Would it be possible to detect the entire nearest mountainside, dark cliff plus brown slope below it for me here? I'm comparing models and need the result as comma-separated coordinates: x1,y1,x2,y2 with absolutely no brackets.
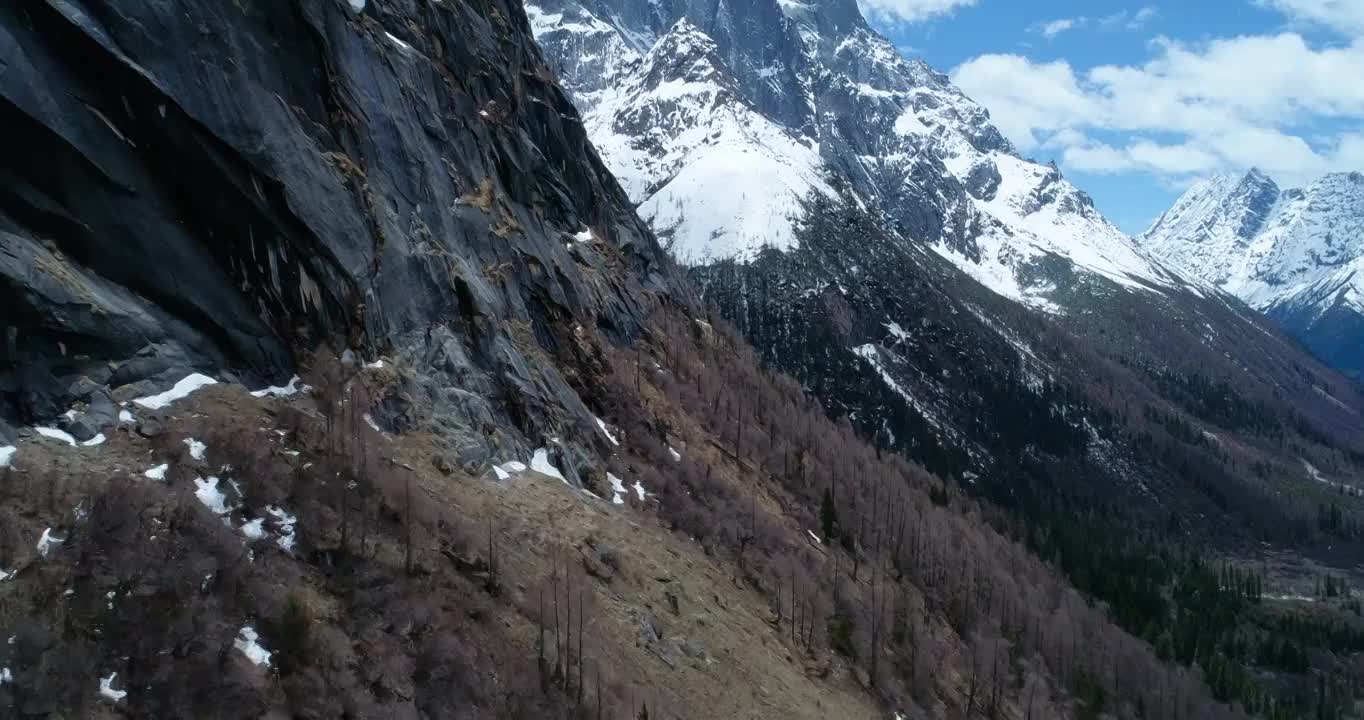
0,0,1249,719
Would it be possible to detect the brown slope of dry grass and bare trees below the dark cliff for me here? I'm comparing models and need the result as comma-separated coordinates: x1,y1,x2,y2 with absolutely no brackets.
0,310,1233,719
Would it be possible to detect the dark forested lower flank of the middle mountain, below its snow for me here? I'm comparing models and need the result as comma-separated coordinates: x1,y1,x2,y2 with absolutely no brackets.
692,190,1364,717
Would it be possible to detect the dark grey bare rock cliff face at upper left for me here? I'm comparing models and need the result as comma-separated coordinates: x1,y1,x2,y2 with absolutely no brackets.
0,0,668,457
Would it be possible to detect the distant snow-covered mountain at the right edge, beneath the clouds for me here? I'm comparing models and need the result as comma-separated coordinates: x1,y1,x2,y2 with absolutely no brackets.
1142,170,1364,378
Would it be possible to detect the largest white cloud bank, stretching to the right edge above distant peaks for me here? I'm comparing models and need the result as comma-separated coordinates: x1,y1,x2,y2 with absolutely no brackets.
952,29,1364,183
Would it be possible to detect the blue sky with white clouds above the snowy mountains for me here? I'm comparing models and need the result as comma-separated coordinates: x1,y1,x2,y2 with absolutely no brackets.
861,0,1364,233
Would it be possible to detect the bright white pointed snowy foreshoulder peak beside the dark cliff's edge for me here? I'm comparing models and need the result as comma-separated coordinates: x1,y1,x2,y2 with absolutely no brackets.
553,12,829,265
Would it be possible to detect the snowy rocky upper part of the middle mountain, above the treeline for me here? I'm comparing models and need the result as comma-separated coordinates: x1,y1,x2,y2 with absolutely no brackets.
527,0,1181,311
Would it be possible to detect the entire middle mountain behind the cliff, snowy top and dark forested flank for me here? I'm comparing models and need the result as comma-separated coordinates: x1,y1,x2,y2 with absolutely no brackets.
528,0,1364,716
